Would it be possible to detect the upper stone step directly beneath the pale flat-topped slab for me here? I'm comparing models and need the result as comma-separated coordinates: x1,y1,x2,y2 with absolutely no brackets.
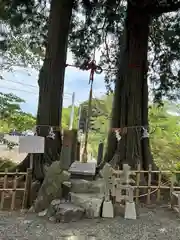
63,179,104,193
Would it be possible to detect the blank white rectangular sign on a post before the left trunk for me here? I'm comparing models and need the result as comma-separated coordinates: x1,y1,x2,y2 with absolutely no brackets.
19,136,44,153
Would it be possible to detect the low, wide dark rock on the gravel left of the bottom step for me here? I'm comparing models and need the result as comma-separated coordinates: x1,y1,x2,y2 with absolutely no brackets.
48,201,84,222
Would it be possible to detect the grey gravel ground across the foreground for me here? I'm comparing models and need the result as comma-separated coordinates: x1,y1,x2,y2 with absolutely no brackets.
0,207,180,240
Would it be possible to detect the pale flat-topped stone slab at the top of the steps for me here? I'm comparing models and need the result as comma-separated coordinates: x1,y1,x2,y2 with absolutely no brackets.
69,161,97,176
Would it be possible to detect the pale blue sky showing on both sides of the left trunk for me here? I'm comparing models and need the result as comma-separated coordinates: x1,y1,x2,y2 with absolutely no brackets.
0,52,106,115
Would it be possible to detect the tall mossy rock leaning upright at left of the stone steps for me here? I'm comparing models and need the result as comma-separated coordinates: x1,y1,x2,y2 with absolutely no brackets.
34,161,70,212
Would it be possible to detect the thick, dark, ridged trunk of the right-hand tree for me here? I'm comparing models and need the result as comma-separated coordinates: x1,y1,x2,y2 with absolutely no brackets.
105,3,153,169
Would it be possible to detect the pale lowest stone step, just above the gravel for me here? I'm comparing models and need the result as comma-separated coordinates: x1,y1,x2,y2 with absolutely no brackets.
70,192,104,218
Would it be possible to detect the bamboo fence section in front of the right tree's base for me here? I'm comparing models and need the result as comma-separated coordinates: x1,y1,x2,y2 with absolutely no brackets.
116,165,180,204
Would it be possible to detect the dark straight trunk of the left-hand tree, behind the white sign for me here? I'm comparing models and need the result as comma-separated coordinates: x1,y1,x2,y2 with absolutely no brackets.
14,0,74,180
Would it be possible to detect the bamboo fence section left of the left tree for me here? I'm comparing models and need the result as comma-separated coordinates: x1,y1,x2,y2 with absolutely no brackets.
0,169,32,210
